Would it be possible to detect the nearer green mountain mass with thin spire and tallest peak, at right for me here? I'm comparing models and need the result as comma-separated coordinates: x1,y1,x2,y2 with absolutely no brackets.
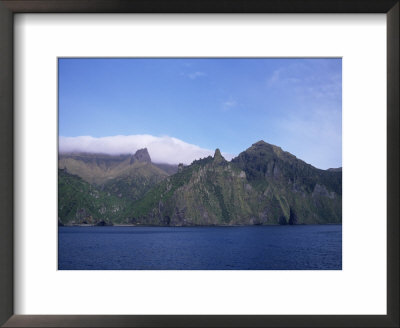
132,141,342,225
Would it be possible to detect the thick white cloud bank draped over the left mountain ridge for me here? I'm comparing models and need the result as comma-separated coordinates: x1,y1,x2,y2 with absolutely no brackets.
59,134,233,164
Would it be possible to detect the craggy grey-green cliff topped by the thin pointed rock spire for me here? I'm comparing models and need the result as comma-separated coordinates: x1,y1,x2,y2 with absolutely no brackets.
133,150,256,225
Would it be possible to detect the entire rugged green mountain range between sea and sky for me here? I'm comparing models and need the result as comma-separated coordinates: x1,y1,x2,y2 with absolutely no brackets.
59,141,342,226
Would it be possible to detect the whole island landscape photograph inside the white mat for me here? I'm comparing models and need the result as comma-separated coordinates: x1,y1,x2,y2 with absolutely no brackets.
57,57,343,270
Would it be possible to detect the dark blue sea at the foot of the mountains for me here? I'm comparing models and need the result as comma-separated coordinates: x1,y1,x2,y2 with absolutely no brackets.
58,225,342,270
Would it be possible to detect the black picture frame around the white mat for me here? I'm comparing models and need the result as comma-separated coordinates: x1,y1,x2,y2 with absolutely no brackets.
0,0,400,327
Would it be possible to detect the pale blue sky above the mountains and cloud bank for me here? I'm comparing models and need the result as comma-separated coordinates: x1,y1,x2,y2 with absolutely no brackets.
59,58,342,169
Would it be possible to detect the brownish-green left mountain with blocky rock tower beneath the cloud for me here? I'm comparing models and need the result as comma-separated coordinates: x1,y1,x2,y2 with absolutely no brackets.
58,148,169,224
